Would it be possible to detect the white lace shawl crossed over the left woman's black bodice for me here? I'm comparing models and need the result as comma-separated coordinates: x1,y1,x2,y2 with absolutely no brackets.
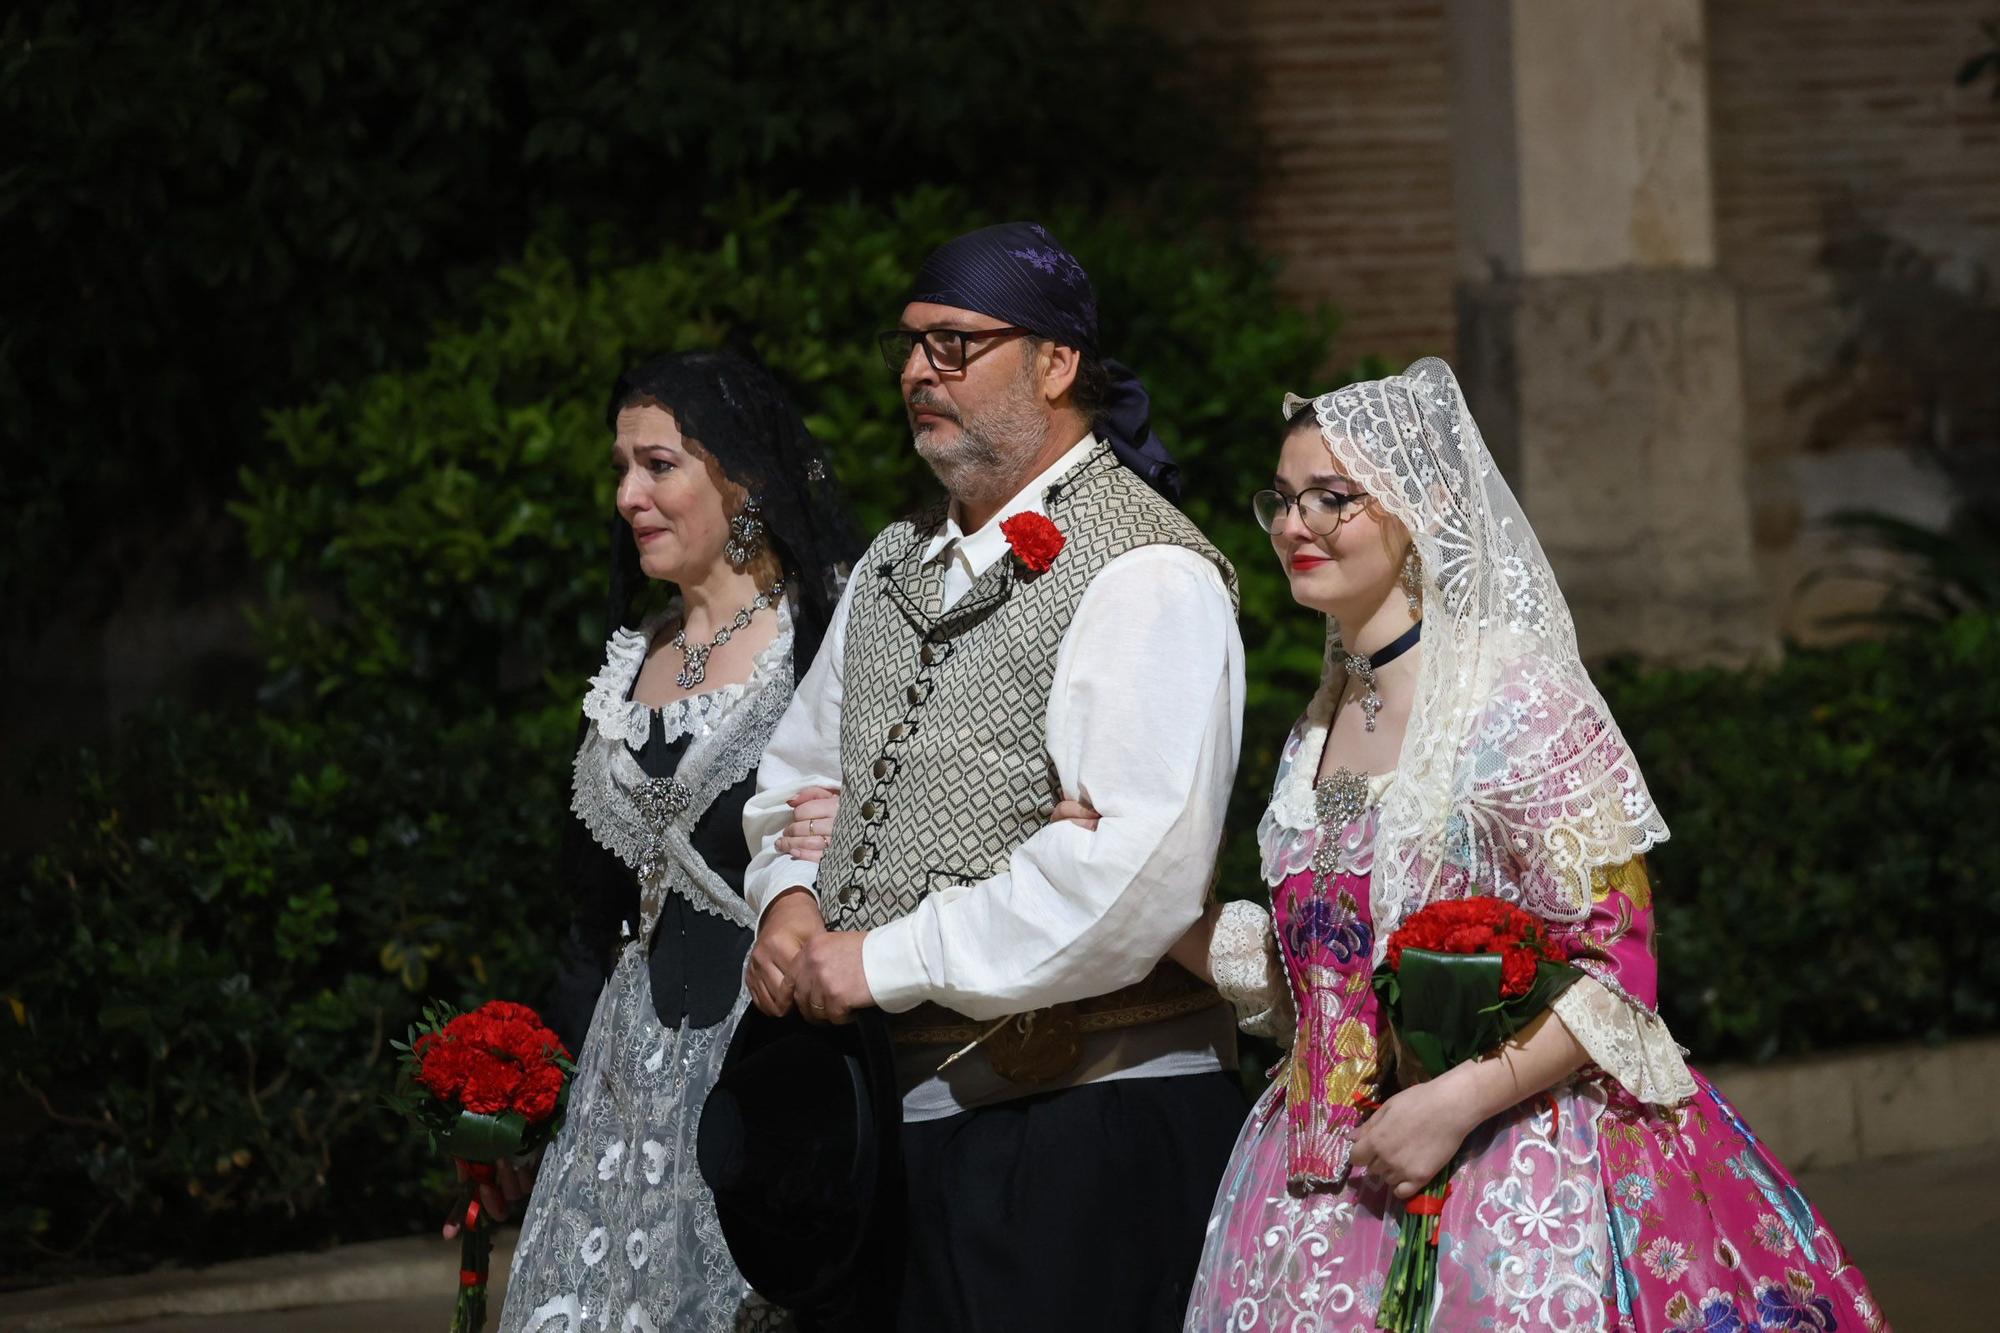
570,602,792,939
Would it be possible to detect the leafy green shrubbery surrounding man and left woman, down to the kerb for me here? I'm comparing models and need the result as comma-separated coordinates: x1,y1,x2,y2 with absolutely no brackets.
0,171,1330,1275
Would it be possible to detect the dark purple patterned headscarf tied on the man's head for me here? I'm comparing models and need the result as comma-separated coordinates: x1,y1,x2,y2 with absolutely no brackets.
910,222,1180,500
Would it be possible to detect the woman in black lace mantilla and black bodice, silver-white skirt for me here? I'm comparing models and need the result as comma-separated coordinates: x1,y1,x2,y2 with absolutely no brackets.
500,352,856,1333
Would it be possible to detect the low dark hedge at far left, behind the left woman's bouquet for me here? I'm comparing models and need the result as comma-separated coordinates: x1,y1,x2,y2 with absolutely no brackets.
0,701,572,1277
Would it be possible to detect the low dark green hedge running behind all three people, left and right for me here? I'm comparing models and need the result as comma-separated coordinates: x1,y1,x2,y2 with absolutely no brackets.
0,618,2000,1275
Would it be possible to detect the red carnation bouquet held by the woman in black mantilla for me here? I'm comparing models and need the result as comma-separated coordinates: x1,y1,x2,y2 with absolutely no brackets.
388,1001,576,1333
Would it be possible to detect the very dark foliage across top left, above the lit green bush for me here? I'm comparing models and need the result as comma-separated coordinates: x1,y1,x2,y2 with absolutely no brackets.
0,0,1252,628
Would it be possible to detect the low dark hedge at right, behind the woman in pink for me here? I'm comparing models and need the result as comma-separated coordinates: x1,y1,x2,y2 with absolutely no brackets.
1604,614,2000,1061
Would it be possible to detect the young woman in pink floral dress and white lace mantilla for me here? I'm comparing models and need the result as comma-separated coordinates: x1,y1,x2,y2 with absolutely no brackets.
1176,360,1888,1333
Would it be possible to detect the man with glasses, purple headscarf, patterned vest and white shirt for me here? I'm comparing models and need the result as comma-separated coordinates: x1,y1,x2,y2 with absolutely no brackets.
744,222,1244,1333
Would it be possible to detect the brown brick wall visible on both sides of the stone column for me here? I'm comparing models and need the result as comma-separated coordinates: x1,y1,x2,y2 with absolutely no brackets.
1138,0,2000,628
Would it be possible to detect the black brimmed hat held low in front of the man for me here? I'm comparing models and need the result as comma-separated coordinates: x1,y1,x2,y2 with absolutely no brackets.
696,1007,904,1329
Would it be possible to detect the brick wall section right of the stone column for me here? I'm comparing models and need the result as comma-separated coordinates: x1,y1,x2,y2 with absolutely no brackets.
1708,0,2000,622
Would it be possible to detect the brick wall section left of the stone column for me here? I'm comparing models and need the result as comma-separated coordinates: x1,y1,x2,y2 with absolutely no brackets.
1140,0,1454,362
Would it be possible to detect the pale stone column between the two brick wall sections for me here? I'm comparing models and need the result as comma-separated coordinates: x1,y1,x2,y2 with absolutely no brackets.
1450,0,1776,662
